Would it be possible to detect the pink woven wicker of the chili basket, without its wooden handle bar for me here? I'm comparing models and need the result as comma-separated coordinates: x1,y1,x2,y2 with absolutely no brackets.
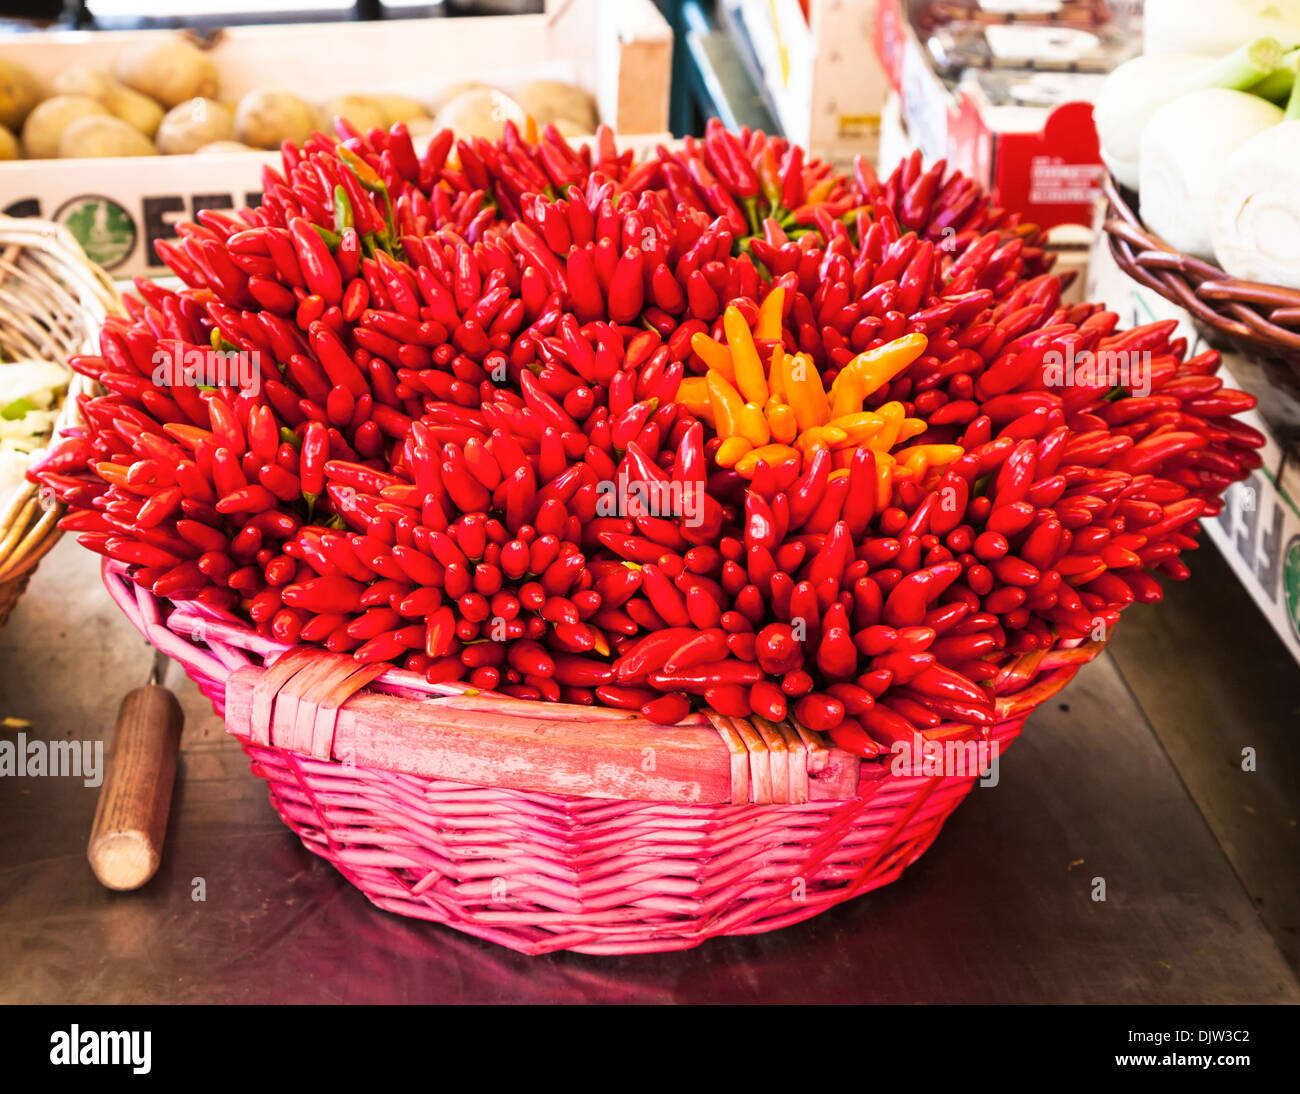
104,563,1100,954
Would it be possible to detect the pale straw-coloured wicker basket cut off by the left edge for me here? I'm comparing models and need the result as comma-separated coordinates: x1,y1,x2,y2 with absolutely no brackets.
0,216,122,626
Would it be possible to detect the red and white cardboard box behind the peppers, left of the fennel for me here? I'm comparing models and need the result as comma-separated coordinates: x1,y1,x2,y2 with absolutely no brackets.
875,0,1104,227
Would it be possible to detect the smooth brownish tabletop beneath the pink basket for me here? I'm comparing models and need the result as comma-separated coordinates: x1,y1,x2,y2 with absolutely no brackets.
0,539,1300,1003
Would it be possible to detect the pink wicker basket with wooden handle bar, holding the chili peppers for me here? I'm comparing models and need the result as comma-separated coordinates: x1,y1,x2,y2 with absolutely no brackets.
104,563,1101,954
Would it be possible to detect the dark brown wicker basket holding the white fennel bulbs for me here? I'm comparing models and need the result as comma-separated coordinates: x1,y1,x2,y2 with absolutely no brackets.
1102,175,1300,388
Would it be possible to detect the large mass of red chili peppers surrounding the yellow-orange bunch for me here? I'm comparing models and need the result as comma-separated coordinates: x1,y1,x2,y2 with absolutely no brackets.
35,114,1262,756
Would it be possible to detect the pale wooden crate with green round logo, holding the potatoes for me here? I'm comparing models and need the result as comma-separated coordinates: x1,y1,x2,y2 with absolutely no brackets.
0,0,672,277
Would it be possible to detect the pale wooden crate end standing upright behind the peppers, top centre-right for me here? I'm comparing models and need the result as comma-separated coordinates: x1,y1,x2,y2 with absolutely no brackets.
722,0,889,170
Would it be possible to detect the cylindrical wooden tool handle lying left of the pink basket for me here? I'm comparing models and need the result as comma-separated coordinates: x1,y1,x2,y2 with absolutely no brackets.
86,685,185,889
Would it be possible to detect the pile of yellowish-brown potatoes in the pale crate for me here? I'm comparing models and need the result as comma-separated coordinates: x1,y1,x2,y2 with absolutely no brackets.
0,38,598,160
